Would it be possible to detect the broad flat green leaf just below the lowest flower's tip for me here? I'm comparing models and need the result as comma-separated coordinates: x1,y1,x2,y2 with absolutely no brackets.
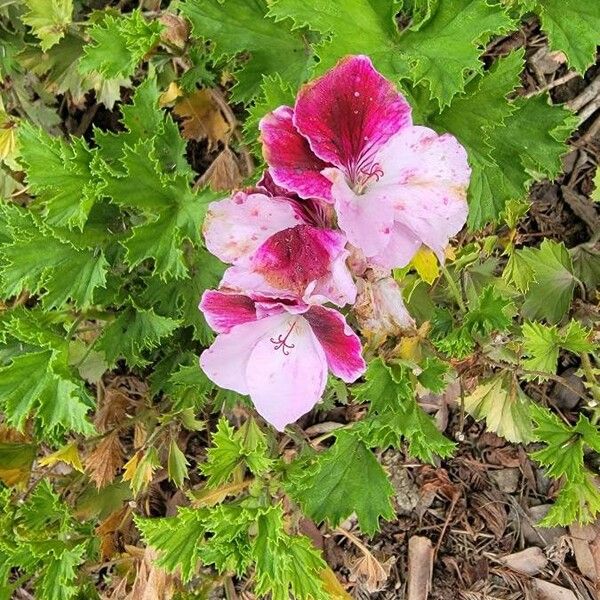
288,431,394,535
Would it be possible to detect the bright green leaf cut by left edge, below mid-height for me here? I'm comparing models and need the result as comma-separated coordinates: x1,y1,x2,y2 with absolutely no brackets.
0,350,94,439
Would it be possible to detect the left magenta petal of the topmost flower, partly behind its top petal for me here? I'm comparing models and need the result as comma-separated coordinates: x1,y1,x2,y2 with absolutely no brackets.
259,106,331,200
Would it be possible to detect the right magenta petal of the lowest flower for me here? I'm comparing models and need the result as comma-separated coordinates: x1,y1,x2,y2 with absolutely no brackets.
304,306,366,383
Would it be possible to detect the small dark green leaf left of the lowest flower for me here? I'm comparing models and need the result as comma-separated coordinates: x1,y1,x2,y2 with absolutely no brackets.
95,304,179,366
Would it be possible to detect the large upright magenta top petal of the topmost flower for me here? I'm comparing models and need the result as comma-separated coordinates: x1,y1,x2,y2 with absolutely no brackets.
293,56,412,173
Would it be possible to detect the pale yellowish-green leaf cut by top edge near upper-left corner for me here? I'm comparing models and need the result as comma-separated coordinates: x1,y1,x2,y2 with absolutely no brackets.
22,0,73,52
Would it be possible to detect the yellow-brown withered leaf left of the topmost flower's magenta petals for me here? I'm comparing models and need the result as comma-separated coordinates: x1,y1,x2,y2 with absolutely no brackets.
173,90,231,149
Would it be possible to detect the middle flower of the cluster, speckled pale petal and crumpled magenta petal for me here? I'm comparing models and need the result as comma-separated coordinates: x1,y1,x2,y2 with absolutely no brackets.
204,188,356,306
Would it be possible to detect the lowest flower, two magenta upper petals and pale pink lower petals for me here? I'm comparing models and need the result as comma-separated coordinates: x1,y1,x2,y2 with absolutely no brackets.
200,291,365,431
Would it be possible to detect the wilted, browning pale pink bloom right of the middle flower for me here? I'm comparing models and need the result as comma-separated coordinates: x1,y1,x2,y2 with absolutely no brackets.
352,277,415,346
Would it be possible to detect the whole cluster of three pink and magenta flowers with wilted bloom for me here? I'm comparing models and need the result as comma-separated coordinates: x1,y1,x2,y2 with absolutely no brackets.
200,56,470,430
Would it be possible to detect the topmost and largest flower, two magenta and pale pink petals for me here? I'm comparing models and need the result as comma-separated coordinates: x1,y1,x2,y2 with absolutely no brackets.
260,56,471,269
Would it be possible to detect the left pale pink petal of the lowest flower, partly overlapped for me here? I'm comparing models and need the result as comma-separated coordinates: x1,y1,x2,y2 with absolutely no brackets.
200,310,289,394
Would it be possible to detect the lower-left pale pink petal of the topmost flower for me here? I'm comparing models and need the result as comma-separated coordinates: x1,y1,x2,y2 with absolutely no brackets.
324,169,394,257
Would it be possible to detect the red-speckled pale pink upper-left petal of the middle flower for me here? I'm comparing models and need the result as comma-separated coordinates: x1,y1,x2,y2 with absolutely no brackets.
204,192,302,264
